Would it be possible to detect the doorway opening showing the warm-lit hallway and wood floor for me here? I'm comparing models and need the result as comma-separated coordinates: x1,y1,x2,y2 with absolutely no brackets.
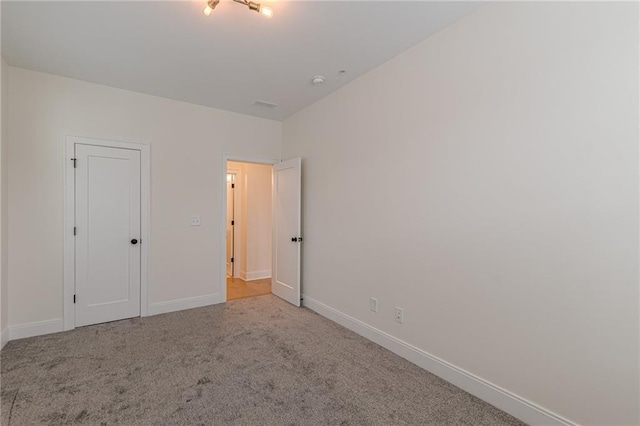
226,161,273,301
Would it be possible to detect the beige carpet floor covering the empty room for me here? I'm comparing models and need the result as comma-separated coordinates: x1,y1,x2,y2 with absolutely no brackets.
0,295,521,426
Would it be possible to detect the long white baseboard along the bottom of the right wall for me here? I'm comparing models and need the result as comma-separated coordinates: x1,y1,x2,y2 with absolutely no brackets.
303,295,576,426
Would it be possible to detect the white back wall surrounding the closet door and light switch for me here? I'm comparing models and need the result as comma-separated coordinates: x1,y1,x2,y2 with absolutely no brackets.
8,67,281,325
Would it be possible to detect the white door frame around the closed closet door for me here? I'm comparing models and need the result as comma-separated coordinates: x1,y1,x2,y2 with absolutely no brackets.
62,136,151,331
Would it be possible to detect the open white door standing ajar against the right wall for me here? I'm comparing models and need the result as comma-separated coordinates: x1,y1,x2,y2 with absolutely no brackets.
271,158,302,306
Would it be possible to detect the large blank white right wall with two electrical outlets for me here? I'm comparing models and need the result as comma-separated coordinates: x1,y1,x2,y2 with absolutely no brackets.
283,2,640,425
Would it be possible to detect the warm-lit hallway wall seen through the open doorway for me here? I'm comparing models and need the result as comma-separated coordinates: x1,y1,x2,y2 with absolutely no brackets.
228,161,273,281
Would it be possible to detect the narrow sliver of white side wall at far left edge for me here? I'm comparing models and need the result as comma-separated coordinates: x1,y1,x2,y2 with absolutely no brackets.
0,58,9,344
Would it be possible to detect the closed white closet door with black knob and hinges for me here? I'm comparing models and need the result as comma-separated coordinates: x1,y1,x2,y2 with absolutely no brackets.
75,144,141,327
